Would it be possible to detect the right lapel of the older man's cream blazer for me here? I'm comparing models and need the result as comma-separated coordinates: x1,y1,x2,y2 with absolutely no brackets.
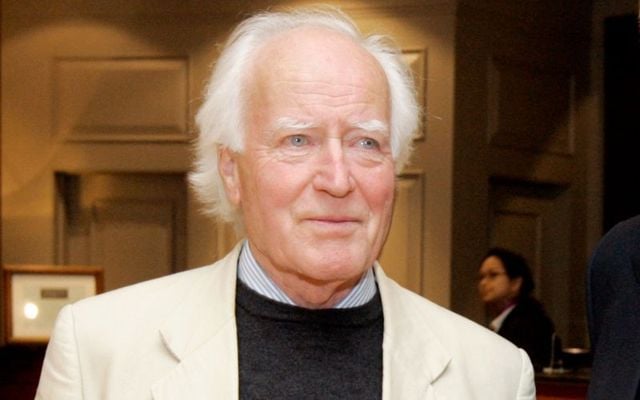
375,265,451,400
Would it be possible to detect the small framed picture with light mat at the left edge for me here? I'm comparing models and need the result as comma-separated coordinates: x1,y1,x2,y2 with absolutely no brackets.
2,265,104,343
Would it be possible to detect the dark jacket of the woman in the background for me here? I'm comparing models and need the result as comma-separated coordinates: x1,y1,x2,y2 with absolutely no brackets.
498,297,555,371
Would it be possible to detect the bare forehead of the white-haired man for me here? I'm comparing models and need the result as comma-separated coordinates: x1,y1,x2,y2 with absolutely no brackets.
247,28,390,131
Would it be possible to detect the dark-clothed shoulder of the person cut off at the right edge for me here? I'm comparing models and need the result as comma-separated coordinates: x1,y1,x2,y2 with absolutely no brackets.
587,215,640,400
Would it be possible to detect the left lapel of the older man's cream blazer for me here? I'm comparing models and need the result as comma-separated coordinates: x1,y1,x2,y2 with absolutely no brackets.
152,245,240,400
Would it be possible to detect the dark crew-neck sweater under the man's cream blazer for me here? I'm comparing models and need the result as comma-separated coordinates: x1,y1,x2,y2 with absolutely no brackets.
236,281,383,400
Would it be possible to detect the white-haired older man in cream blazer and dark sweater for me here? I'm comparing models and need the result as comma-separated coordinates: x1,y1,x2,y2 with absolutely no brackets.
38,9,535,400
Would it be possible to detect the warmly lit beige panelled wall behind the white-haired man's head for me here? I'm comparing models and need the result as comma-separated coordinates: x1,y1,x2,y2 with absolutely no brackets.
2,1,454,294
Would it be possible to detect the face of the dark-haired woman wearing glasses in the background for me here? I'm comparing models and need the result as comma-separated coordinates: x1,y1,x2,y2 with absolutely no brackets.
478,256,522,306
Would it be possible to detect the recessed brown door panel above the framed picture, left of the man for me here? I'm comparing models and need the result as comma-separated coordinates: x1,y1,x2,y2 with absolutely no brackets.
57,173,186,290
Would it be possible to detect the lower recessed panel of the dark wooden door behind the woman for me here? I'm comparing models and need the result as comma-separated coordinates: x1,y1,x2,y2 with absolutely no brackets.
489,181,568,346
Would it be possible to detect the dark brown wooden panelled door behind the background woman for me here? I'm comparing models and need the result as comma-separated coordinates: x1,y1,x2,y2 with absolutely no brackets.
452,0,600,346
